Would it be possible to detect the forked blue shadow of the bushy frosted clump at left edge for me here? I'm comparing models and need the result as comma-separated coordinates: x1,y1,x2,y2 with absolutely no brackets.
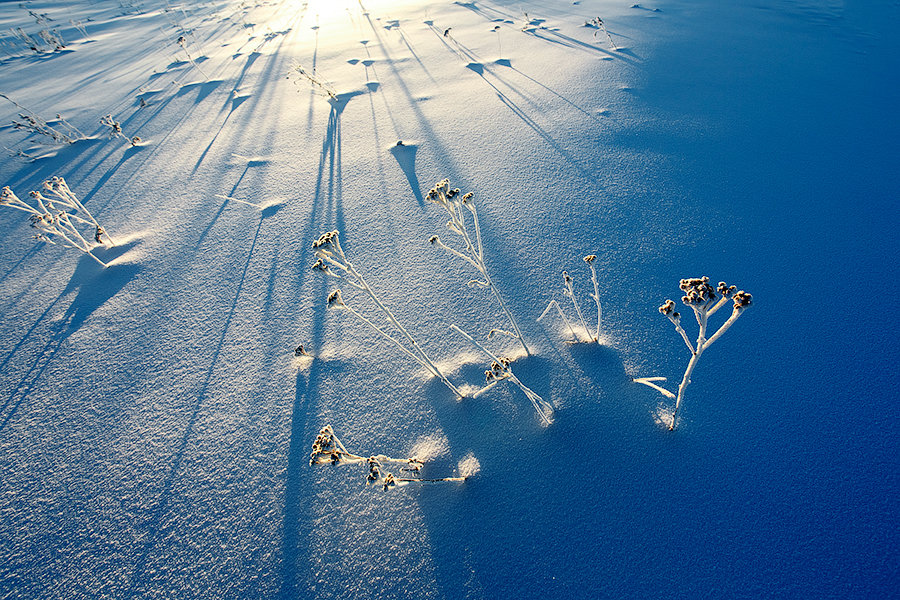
0,243,141,431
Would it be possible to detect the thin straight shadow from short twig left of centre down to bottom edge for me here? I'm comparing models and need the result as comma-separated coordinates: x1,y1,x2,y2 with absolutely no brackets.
123,218,263,598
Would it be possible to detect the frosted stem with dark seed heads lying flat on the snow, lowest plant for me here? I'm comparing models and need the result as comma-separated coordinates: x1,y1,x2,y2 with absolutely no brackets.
309,425,468,490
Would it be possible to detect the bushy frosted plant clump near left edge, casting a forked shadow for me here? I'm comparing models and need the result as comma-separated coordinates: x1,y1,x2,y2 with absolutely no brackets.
0,177,115,267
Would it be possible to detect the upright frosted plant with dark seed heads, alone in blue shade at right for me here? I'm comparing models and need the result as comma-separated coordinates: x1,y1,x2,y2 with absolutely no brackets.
634,277,753,431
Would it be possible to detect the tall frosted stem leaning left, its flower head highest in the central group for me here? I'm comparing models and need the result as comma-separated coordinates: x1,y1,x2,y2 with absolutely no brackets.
426,179,531,356
